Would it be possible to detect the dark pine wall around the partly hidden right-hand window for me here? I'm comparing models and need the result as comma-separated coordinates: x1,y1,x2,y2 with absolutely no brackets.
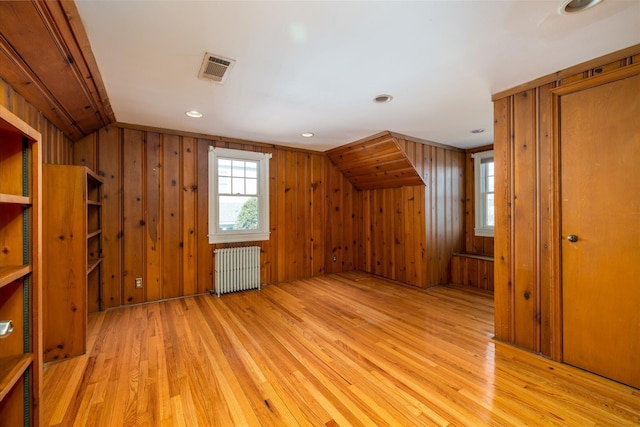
464,145,493,256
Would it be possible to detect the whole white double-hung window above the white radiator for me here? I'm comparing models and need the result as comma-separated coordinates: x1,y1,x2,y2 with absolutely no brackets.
209,147,271,243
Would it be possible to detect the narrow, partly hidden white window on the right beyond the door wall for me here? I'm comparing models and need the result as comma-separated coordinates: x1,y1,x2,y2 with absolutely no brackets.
473,150,495,237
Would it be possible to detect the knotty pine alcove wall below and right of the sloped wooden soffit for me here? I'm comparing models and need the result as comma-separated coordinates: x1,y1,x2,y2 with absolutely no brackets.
355,137,465,287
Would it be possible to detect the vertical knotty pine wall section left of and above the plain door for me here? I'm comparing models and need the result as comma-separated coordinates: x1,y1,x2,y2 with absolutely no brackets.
493,45,640,360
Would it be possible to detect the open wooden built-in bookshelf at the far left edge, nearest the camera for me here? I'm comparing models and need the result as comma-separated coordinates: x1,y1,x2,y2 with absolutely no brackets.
0,105,42,426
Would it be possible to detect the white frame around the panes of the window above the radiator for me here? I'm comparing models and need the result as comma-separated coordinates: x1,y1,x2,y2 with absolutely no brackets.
208,146,271,244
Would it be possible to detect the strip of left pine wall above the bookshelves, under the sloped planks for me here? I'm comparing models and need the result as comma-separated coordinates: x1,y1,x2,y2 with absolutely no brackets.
0,79,73,164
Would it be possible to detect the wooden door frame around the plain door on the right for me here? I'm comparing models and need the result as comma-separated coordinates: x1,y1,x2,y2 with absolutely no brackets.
549,63,640,362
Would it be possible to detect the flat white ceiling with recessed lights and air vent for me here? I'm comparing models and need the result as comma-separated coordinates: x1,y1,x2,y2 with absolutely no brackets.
76,0,640,151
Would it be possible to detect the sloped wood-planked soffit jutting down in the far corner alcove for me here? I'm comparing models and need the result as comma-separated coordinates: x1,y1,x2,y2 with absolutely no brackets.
326,131,425,190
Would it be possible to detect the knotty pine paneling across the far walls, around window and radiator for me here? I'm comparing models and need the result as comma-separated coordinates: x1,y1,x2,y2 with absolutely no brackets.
75,126,465,307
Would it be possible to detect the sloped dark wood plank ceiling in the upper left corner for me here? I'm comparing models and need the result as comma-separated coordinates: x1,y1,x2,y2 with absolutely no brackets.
0,0,115,141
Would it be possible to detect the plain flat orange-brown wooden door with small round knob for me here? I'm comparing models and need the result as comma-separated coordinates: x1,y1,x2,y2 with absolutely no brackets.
559,70,640,387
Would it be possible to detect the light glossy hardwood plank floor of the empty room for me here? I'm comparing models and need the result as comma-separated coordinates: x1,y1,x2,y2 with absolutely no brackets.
43,273,640,426
